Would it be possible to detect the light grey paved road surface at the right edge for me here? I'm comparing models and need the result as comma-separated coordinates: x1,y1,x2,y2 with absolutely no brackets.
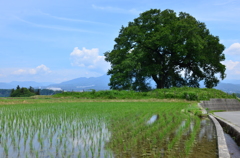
214,111,240,127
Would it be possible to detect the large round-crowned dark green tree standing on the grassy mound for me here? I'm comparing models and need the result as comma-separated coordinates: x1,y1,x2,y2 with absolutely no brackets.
105,9,226,91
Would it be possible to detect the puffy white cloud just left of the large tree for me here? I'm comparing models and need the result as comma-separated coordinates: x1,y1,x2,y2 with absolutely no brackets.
70,47,110,72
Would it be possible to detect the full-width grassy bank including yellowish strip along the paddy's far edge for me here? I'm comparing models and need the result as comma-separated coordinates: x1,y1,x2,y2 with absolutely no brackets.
0,87,237,104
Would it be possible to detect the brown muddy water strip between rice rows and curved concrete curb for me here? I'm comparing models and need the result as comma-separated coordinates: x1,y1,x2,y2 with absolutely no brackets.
189,118,218,158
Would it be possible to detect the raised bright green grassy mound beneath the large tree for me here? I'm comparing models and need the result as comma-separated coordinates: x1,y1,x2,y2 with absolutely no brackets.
53,87,235,101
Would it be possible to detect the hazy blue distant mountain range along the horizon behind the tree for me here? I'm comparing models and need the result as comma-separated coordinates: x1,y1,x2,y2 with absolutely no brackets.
0,75,240,93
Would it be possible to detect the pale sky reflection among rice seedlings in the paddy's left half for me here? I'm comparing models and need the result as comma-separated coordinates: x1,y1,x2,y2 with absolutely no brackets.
0,117,113,158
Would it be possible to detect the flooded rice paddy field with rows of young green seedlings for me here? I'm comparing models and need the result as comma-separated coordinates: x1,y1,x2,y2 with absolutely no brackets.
0,99,217,158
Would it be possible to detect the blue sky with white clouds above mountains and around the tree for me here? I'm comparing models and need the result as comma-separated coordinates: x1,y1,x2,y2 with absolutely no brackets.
0,0,240,83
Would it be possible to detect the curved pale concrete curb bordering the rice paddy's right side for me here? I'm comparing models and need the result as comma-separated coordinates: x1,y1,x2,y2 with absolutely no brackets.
208,115,231,158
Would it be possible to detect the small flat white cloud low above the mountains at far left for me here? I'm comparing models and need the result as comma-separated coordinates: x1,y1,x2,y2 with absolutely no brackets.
12,64,51,75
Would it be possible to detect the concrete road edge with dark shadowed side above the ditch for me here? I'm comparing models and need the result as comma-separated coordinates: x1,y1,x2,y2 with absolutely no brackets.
213,115,240,145
